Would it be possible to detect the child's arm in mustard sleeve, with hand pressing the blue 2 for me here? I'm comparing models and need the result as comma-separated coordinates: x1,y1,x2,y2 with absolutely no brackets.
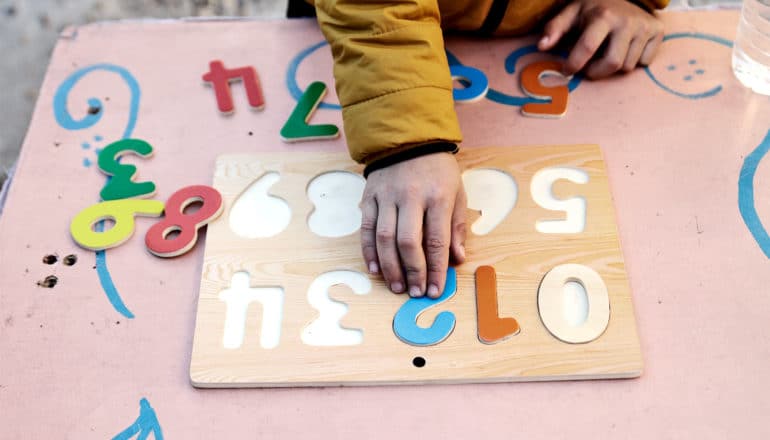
315,0,466,297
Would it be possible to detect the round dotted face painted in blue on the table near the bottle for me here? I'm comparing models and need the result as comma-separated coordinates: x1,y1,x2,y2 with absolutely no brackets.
645,33,732,99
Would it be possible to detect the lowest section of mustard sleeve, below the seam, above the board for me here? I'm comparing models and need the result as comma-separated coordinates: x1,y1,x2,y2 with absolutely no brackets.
342,86,462,165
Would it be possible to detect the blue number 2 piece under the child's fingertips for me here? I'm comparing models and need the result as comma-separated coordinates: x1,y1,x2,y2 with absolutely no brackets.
393,267,457,347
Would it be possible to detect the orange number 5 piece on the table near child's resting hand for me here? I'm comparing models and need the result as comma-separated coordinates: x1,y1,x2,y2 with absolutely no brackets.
519,61,569,118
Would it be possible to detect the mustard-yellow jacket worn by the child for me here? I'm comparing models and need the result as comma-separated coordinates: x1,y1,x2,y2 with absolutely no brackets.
310,0,668,170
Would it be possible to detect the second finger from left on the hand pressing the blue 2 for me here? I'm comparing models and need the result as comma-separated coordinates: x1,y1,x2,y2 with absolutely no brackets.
375,200,404,293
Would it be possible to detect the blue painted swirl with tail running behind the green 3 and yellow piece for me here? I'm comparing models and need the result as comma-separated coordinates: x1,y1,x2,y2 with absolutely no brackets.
53,64,141,319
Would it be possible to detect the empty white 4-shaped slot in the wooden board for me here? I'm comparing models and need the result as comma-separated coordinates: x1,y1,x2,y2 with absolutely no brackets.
219,272,284,350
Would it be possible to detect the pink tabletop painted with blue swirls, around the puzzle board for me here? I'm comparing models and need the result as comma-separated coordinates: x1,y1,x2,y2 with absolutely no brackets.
0,11,770,440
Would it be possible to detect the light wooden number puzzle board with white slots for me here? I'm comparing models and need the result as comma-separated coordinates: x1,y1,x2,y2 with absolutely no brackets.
190,146,642,387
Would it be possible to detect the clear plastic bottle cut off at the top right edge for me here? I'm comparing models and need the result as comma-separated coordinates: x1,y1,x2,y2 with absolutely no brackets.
733,0,770,95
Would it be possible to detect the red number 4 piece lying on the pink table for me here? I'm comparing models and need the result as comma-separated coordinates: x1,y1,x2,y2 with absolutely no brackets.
203,60,265,115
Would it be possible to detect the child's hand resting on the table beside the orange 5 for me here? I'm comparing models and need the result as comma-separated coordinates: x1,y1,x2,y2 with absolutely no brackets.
538,0,663,79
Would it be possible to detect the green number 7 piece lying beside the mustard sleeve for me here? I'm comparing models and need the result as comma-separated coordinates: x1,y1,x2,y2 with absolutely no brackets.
281,81,340,142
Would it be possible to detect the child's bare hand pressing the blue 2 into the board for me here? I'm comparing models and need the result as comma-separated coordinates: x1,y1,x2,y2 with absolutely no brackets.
361,153,467,298
